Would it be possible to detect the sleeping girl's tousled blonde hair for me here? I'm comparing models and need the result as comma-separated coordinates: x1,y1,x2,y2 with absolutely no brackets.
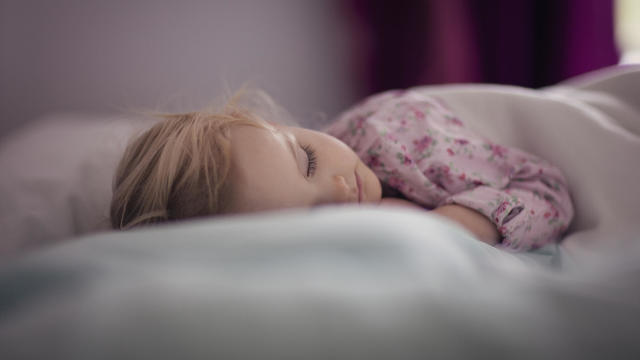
110,90,288,229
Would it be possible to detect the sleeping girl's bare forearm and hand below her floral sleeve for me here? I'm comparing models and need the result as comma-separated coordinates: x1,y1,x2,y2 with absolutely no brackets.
380,198,500,245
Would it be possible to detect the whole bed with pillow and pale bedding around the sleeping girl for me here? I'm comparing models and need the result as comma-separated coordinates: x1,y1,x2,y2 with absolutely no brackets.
0,66,640,359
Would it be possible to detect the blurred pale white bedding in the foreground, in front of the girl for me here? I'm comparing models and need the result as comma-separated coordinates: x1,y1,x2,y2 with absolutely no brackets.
0,207,640,360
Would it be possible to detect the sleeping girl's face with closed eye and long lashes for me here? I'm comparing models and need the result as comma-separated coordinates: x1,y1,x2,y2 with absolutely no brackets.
230,125,381,212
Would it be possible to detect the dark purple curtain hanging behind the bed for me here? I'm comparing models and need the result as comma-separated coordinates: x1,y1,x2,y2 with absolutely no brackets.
345,0,618,93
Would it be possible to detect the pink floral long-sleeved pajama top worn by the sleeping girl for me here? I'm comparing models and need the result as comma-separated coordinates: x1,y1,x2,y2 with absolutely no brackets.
327,90,573,251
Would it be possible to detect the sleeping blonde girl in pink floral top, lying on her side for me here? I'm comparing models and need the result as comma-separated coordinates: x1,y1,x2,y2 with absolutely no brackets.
111,90,573,251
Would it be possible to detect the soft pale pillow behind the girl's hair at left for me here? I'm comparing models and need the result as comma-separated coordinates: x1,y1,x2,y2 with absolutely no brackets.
0,114,148,255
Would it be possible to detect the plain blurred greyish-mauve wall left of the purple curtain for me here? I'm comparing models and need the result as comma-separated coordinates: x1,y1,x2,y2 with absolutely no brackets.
0,0,355,138
